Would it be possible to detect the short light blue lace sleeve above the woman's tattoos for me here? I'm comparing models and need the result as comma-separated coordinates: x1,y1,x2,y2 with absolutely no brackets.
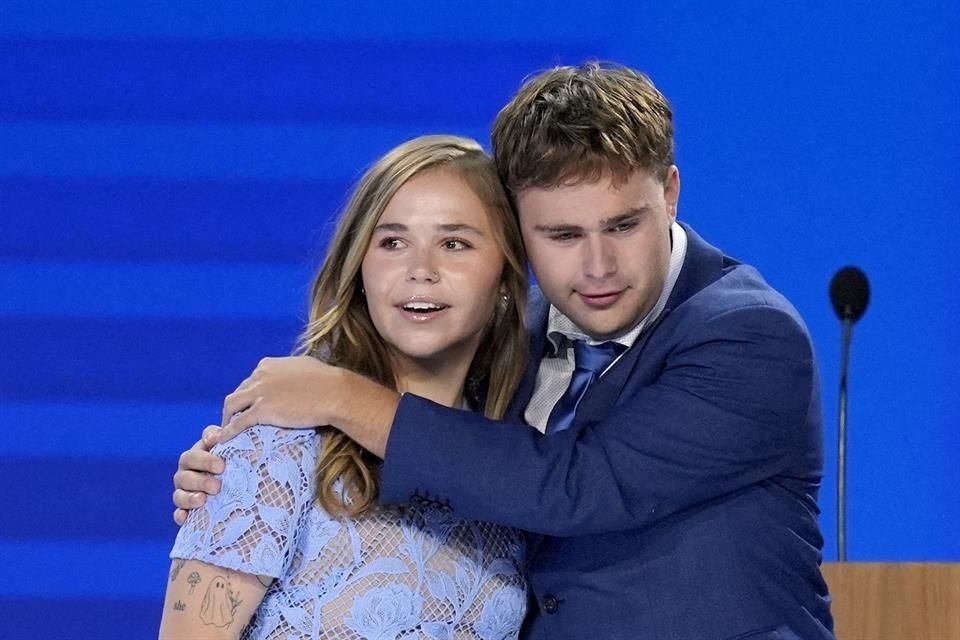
170,426,320,578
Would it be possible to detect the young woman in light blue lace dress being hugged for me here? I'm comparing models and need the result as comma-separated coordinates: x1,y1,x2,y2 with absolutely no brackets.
160,136,527,640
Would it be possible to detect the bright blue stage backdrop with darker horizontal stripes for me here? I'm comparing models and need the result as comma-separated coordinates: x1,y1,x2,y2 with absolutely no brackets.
0,0,960,640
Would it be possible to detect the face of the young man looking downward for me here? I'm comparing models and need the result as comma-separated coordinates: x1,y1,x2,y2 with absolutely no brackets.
517,166,680,340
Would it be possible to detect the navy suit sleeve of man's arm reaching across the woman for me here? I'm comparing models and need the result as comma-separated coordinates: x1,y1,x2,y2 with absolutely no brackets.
381,306,814,536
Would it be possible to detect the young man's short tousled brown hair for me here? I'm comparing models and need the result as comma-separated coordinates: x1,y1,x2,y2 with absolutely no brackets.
493,62,674,194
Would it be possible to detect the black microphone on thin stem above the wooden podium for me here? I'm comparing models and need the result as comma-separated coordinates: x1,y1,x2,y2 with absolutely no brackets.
830,266,870,562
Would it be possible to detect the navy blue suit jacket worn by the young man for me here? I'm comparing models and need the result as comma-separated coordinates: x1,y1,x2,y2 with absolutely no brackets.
381,227,833,640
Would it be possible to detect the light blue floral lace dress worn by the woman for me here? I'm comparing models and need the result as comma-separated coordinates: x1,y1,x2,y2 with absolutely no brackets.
170,427,526,640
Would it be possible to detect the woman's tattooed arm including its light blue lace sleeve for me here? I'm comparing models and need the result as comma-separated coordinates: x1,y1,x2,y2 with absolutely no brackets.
160,426,319,639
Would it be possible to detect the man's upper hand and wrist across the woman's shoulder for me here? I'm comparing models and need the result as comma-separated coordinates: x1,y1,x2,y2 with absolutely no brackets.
212,356,400,456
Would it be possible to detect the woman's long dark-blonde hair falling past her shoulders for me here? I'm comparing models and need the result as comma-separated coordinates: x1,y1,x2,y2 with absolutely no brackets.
297,135,527,517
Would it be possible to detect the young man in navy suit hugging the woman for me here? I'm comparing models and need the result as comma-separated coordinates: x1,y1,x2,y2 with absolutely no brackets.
175,64,833,640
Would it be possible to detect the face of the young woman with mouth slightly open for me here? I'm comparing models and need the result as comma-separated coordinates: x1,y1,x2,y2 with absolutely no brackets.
361,168,504,366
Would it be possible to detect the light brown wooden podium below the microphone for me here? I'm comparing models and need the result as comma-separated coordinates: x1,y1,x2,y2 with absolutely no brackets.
823,562,960,640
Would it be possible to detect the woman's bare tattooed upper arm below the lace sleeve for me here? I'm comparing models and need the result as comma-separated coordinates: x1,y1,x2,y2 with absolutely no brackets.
160,558,273,640
